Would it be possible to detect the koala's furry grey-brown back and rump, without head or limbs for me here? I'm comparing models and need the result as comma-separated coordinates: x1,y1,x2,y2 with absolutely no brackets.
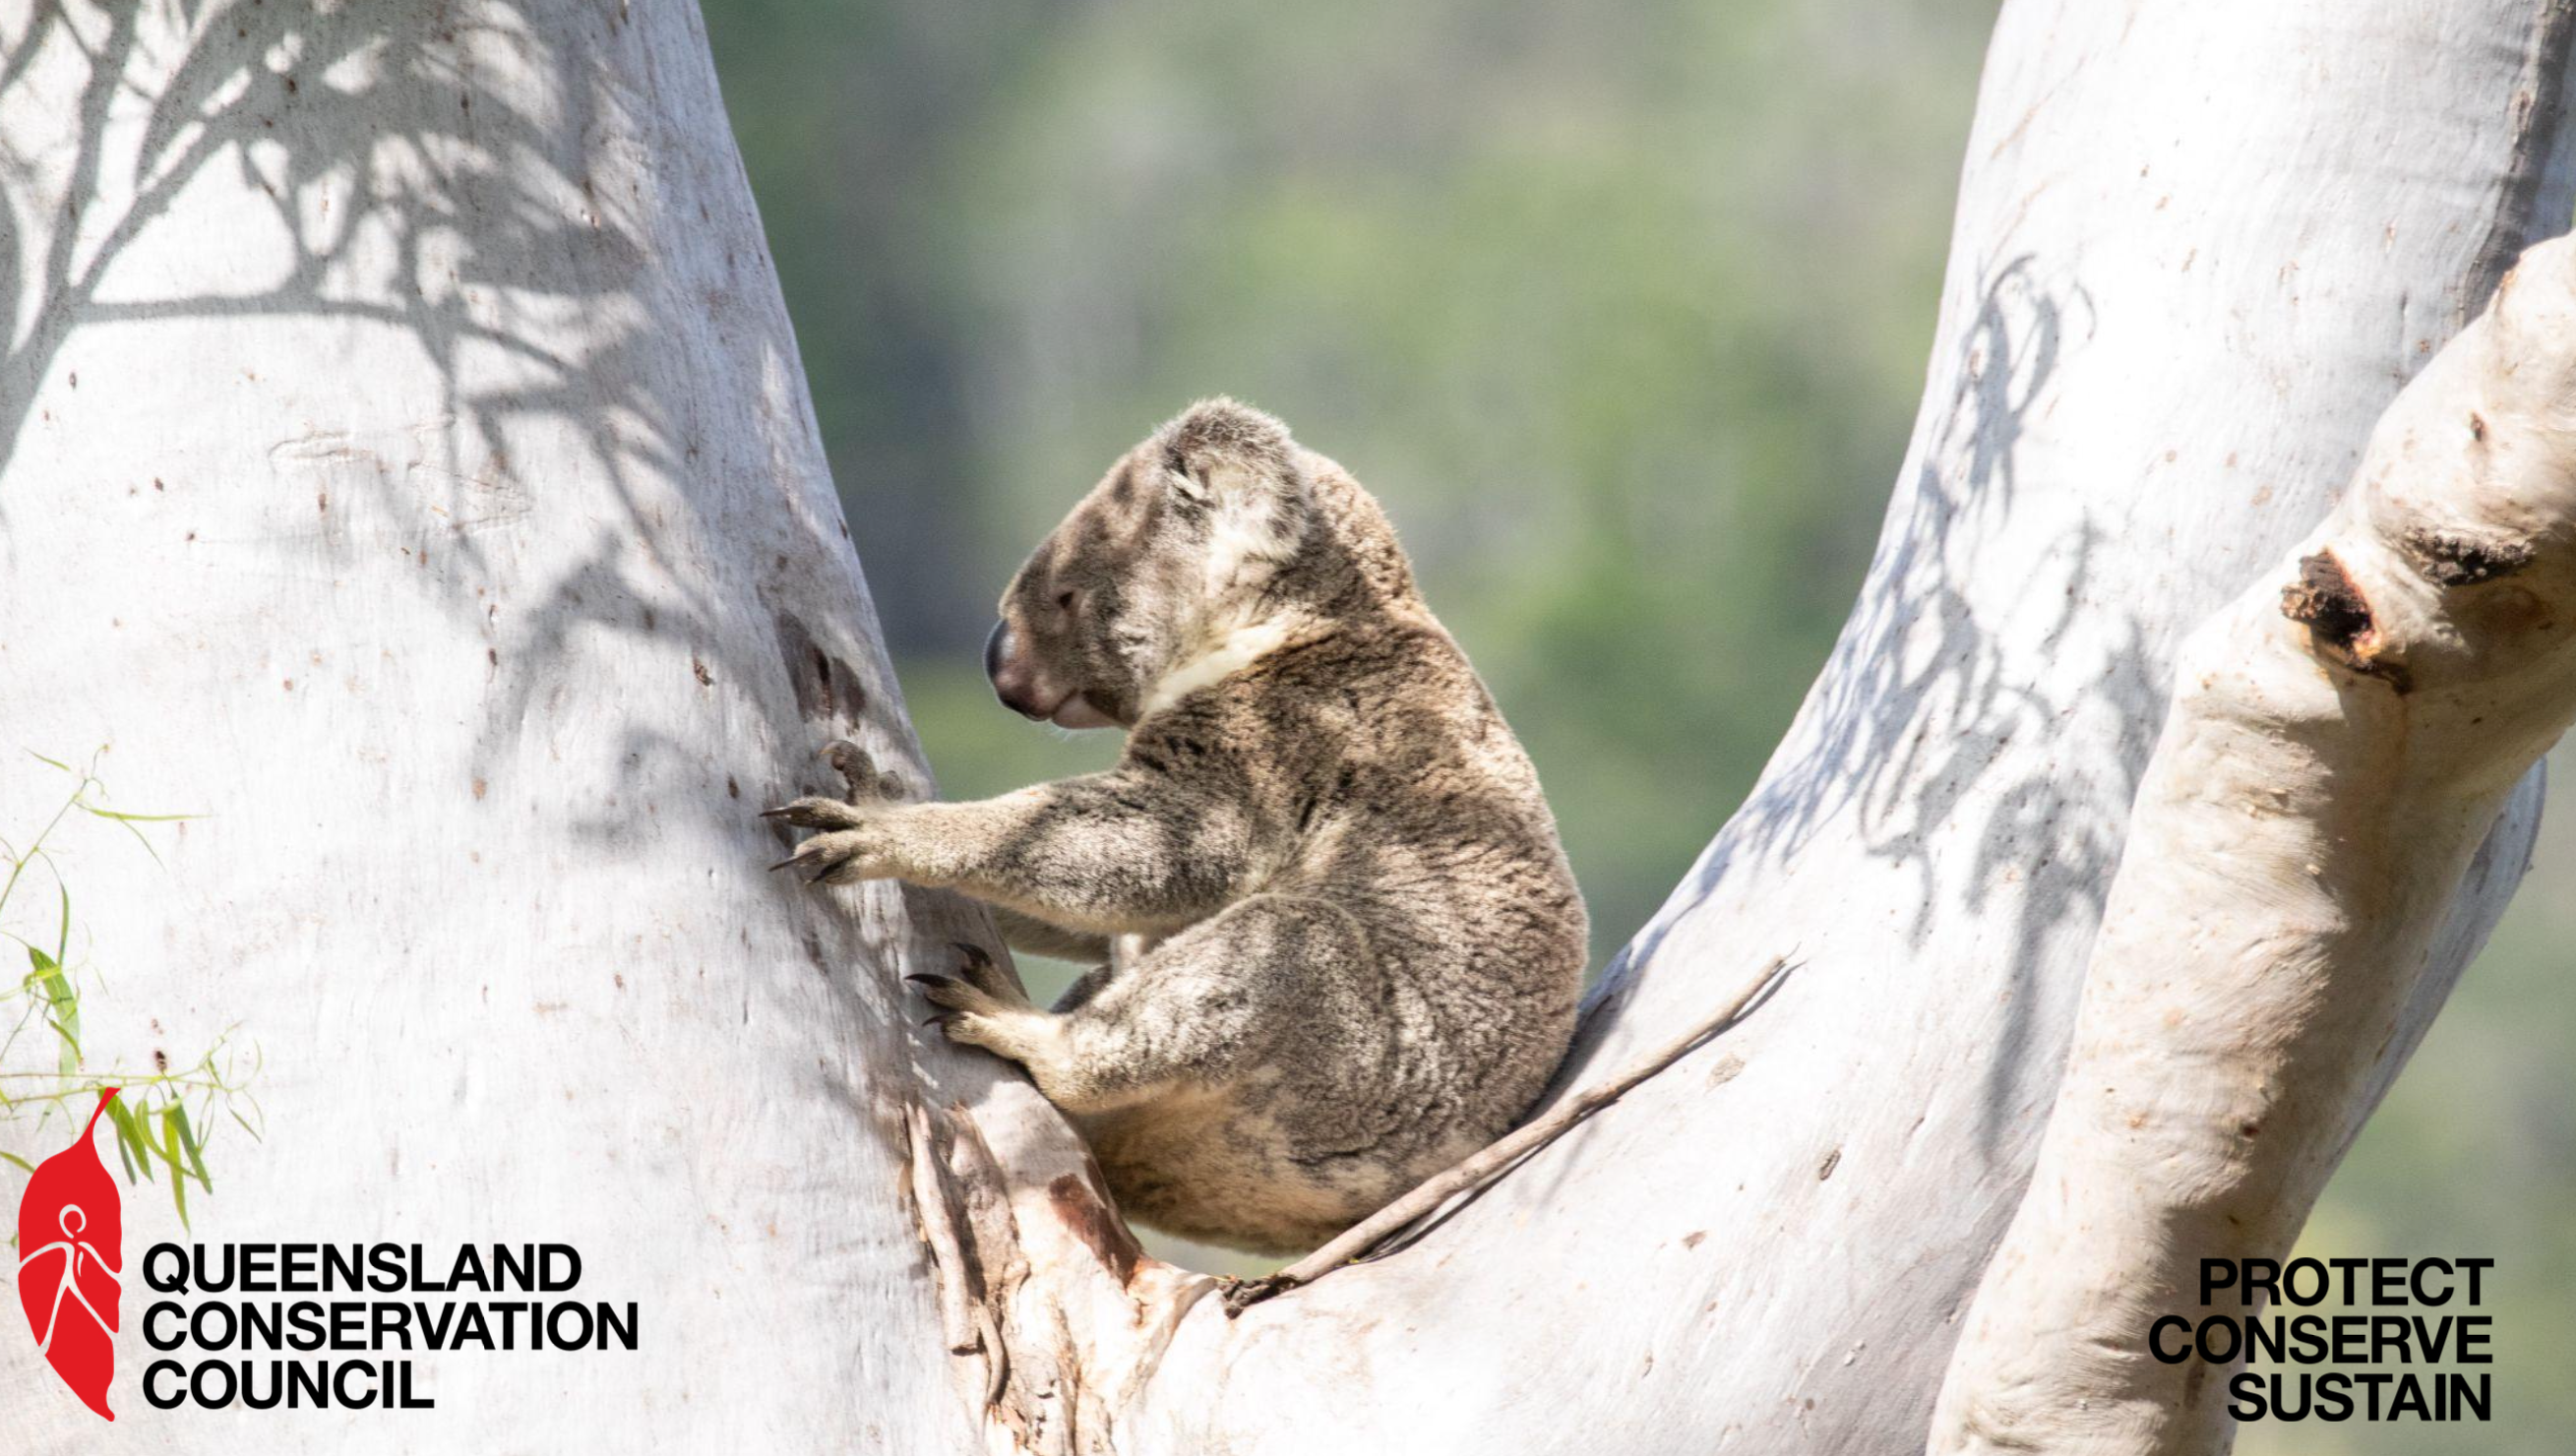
1082,461,1587,1249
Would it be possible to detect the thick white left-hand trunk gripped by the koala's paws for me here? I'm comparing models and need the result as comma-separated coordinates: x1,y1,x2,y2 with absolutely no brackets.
0,0,1056,1453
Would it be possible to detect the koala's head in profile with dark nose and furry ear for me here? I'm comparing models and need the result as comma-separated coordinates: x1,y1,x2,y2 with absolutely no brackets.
984,402,1306,729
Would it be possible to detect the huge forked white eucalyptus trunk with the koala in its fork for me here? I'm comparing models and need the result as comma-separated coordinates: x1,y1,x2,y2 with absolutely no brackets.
0,0,2576,1453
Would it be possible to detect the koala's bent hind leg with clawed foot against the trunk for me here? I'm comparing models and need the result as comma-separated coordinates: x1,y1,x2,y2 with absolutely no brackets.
914,894,1376,1114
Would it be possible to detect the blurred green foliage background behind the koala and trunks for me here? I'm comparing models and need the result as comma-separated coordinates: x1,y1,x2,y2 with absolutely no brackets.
705,0,2576,1456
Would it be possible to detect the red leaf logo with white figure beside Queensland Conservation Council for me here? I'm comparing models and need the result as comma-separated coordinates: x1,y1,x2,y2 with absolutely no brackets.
18,1087,126,1420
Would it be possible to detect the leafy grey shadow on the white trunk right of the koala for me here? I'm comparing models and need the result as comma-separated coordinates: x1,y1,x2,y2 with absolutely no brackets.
1551,253,2167,1144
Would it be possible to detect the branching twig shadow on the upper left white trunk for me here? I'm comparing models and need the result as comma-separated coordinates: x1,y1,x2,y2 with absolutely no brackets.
0,0,917,793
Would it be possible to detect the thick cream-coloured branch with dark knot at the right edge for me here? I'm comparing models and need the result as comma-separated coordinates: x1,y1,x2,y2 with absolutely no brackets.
1932,240,2576,1456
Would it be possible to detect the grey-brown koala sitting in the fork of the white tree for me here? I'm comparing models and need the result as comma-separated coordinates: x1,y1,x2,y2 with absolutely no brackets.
770,399,1584,1255
